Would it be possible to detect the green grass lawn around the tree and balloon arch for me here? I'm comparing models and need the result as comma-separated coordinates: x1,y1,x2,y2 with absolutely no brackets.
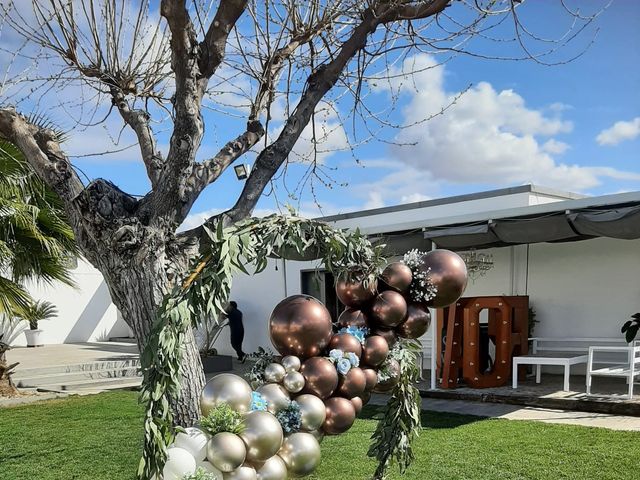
0,392,640,480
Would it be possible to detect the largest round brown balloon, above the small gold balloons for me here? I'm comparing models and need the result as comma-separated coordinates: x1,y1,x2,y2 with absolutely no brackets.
269,295,333,358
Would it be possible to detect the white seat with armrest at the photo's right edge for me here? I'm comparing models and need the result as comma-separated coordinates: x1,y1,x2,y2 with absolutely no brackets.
587,341,640,400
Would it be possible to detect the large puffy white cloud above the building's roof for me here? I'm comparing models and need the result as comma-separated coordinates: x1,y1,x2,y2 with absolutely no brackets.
378,55,636,194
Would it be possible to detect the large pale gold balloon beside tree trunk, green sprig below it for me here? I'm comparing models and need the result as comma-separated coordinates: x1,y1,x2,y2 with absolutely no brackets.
200,373,252,416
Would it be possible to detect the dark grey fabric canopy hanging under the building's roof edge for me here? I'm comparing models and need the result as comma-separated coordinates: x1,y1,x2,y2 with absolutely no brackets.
424,204,640,250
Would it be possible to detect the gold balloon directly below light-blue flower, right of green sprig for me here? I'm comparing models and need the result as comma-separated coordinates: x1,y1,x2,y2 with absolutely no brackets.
240,411,284,462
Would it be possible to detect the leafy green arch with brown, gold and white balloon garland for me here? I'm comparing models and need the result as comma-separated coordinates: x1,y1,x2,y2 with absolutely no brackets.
139,217,466,480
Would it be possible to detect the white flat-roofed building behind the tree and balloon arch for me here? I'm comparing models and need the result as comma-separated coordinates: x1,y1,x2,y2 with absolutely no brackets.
12,185,640,366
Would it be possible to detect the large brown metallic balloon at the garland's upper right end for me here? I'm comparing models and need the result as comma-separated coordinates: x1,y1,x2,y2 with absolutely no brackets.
419,250,468,308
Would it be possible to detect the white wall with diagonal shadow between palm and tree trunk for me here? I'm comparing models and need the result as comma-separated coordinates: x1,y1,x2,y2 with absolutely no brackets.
15,259,129,346
